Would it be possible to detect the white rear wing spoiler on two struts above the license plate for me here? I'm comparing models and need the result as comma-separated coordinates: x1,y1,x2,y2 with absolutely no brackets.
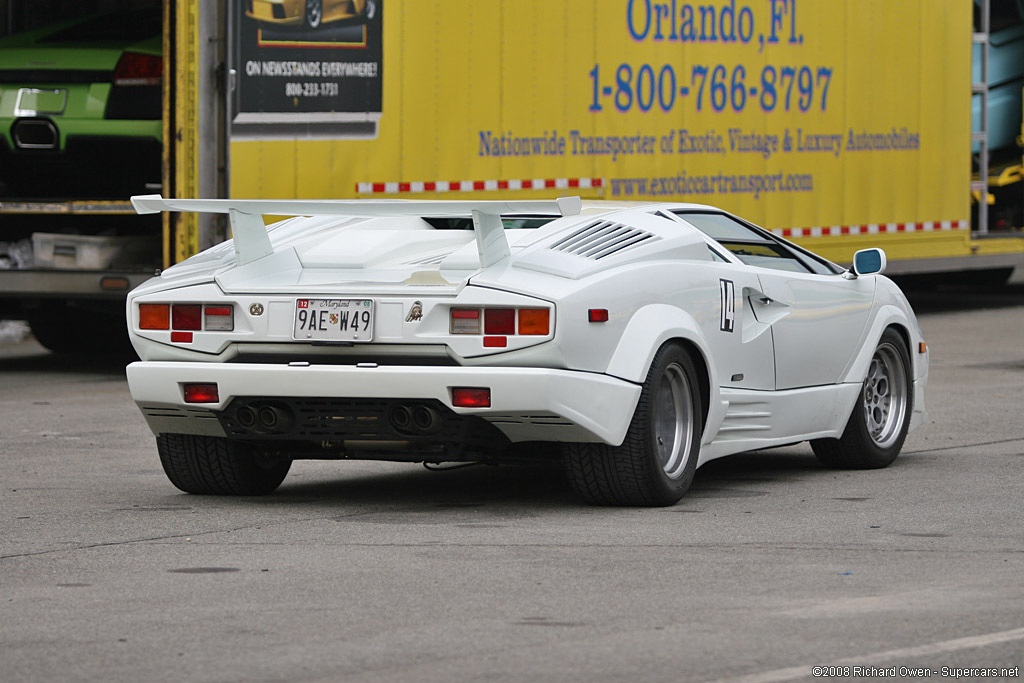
131,195,583,267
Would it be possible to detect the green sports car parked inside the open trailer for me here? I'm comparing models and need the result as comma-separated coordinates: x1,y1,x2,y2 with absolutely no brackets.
0,9,164,200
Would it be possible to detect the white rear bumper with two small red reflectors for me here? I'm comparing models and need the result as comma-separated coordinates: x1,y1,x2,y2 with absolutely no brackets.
127,361,640,445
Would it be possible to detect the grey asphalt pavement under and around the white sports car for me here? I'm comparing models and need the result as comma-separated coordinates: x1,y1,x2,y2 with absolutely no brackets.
0,279,1024,683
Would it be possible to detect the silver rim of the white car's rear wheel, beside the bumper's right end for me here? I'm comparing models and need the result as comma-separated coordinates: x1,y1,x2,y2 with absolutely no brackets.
654,362,693,479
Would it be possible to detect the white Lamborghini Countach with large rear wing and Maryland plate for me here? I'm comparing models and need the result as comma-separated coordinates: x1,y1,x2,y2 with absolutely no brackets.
121,196,928,506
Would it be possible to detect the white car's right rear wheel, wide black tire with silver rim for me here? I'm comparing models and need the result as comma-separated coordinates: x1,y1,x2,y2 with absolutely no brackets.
563,343,703,507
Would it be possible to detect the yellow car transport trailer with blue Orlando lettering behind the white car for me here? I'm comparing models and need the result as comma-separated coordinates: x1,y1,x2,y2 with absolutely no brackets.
0,0,1024,352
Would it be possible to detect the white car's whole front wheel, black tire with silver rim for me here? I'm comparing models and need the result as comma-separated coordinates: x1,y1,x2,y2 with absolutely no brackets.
811,329,913,470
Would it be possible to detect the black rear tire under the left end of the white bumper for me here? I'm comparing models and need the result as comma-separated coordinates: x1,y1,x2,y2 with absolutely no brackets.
157,434,292,496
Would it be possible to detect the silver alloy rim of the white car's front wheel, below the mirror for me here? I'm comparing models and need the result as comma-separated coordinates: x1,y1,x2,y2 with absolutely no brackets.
861,342,907,449
